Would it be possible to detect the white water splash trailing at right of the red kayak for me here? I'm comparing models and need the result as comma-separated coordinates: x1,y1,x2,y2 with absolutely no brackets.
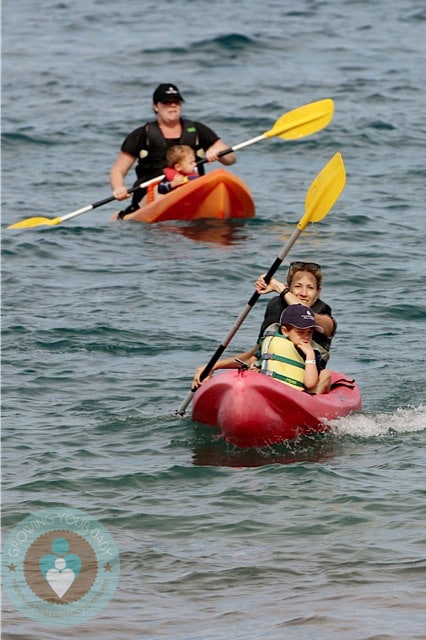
330,404,426,437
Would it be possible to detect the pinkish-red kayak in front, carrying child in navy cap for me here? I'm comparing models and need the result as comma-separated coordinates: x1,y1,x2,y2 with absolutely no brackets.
192,369,362,447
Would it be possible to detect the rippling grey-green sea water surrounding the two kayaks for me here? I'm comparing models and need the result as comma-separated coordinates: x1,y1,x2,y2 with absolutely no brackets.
2,0,426,640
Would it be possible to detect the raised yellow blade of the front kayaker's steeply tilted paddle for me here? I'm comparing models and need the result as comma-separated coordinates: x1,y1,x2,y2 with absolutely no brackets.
297,153,346,231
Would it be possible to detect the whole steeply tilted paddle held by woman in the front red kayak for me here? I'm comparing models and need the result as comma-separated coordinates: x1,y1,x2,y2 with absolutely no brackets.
176,153,346,416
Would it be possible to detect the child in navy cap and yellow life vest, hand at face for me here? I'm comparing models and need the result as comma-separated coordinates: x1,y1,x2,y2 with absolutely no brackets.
259,304,328,393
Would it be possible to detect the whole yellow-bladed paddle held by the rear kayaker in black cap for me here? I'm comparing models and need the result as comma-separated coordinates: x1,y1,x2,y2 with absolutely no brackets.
8,98,334,229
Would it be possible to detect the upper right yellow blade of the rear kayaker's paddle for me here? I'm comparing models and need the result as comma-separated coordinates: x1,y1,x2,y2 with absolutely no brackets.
263,98,334,140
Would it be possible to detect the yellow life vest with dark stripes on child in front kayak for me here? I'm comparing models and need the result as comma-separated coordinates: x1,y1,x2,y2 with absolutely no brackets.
259,325,305,391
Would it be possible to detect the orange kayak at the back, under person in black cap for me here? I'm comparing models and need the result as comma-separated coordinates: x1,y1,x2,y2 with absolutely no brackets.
113,169,255,223
